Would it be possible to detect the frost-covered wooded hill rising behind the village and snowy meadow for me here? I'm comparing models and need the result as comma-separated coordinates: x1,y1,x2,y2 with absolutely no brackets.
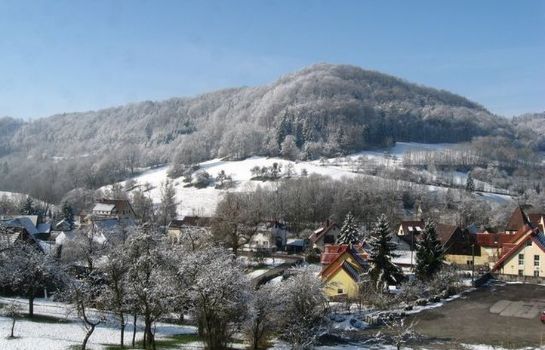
0,64,528,201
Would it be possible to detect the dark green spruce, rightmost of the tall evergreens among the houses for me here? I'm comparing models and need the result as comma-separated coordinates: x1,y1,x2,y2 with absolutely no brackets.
415,219,443,281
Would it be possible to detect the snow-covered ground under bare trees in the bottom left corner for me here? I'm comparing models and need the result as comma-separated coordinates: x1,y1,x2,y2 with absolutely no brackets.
0,298,197,350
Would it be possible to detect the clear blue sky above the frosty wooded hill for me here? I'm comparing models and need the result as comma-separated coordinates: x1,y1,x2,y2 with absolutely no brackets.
0,0,545,120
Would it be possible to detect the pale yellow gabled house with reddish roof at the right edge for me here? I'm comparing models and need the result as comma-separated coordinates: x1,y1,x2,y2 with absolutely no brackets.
492,226,545,278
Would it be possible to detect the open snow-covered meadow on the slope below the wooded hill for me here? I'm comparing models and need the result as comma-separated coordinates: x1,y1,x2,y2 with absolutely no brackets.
103,142,511,216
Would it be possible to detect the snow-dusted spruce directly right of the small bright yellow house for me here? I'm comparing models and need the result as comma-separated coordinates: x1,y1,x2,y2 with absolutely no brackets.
368,214,403,291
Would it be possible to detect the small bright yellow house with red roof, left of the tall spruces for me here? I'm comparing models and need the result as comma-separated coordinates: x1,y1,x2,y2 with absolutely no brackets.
320,244,368,299
